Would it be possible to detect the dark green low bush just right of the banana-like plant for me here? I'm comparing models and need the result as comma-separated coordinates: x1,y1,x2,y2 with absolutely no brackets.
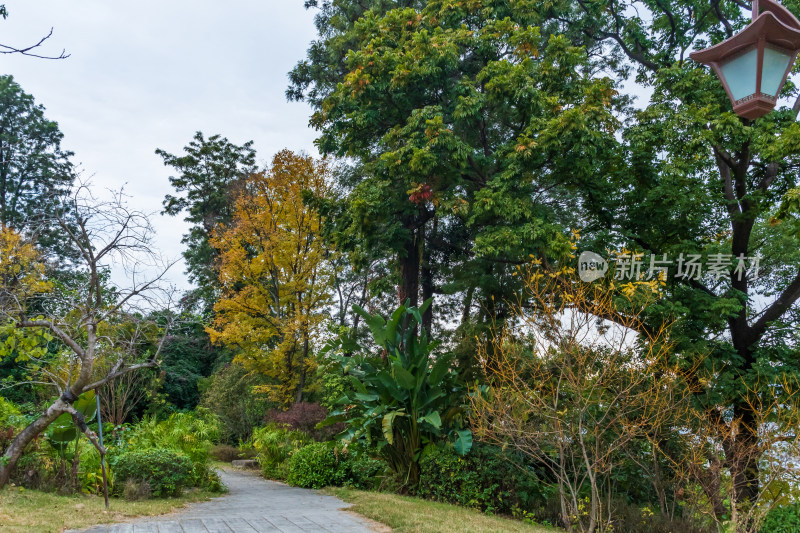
417,444,549,515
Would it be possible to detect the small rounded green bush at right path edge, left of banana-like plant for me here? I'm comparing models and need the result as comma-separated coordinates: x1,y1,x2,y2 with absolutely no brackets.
287,442,383,489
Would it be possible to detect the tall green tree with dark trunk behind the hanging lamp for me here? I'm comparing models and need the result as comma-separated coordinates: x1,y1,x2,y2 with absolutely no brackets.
520,0,800,528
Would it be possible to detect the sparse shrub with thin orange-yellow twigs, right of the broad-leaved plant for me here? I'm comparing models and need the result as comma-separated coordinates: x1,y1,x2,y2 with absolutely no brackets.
471,271,687,533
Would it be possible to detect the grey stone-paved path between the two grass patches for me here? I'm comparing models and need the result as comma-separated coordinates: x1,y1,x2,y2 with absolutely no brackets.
68,470,387,533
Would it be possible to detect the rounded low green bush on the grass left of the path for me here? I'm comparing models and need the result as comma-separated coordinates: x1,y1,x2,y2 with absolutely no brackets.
110,448,193,497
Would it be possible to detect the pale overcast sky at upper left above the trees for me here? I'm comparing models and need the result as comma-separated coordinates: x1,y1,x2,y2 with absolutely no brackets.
0,0,317,286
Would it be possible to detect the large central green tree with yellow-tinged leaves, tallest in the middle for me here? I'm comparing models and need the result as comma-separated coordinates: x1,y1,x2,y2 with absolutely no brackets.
287,1,616,327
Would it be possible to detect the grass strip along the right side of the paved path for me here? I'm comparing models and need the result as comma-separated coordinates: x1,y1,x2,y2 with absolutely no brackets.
325,487,563,533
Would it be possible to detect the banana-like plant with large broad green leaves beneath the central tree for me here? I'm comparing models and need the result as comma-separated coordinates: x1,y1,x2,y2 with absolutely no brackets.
326,300,472,488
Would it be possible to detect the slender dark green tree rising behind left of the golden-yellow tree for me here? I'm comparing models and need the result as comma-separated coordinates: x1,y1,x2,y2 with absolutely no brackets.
156,131,256,312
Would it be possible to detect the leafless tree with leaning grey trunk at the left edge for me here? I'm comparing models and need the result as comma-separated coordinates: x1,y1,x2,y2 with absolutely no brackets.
0,184,174,487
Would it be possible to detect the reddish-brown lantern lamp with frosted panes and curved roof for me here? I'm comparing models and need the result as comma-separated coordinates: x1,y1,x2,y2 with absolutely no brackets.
689,0,800,119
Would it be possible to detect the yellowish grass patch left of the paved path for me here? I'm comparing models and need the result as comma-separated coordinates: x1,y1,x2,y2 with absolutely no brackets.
0,487,219,533
